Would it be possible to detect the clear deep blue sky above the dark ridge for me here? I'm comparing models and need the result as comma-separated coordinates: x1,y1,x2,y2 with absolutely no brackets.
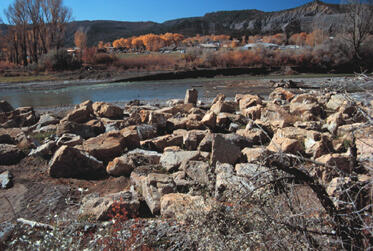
0,0,340,22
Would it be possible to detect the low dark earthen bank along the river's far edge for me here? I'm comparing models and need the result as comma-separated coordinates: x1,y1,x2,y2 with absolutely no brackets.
0,67,353,91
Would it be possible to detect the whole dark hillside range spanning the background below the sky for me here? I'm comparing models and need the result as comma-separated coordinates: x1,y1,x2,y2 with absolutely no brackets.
0,1,341,46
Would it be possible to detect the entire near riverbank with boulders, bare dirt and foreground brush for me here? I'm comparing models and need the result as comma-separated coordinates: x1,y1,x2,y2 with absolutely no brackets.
0,83,373,250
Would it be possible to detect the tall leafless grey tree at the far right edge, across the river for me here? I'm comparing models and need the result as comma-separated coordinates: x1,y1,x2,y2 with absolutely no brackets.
341,0,373,61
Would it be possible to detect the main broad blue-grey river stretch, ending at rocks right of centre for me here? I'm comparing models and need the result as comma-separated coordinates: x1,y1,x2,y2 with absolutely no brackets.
0,78,270,107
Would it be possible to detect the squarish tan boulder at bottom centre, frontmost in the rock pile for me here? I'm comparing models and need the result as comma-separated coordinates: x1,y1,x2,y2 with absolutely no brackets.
161,193,209,220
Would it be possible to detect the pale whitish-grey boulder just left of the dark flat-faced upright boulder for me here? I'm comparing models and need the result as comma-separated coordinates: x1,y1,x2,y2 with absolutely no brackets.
160,151,200,171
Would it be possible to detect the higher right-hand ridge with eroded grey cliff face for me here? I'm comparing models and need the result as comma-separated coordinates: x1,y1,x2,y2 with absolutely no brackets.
162,1,342,35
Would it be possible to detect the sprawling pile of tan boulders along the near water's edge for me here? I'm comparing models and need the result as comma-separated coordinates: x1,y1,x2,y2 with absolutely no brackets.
0,86,373,220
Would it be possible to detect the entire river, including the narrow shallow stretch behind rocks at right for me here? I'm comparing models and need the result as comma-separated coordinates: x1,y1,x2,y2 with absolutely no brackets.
0,76,373,108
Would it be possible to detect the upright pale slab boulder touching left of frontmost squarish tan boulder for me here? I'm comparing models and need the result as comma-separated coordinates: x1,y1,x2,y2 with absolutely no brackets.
142,173,176,215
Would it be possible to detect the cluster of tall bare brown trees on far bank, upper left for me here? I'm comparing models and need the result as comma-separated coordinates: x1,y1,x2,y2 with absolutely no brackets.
3,0,72,66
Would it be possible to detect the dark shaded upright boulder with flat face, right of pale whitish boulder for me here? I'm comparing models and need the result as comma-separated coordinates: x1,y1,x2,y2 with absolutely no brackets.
210,134,242,165
